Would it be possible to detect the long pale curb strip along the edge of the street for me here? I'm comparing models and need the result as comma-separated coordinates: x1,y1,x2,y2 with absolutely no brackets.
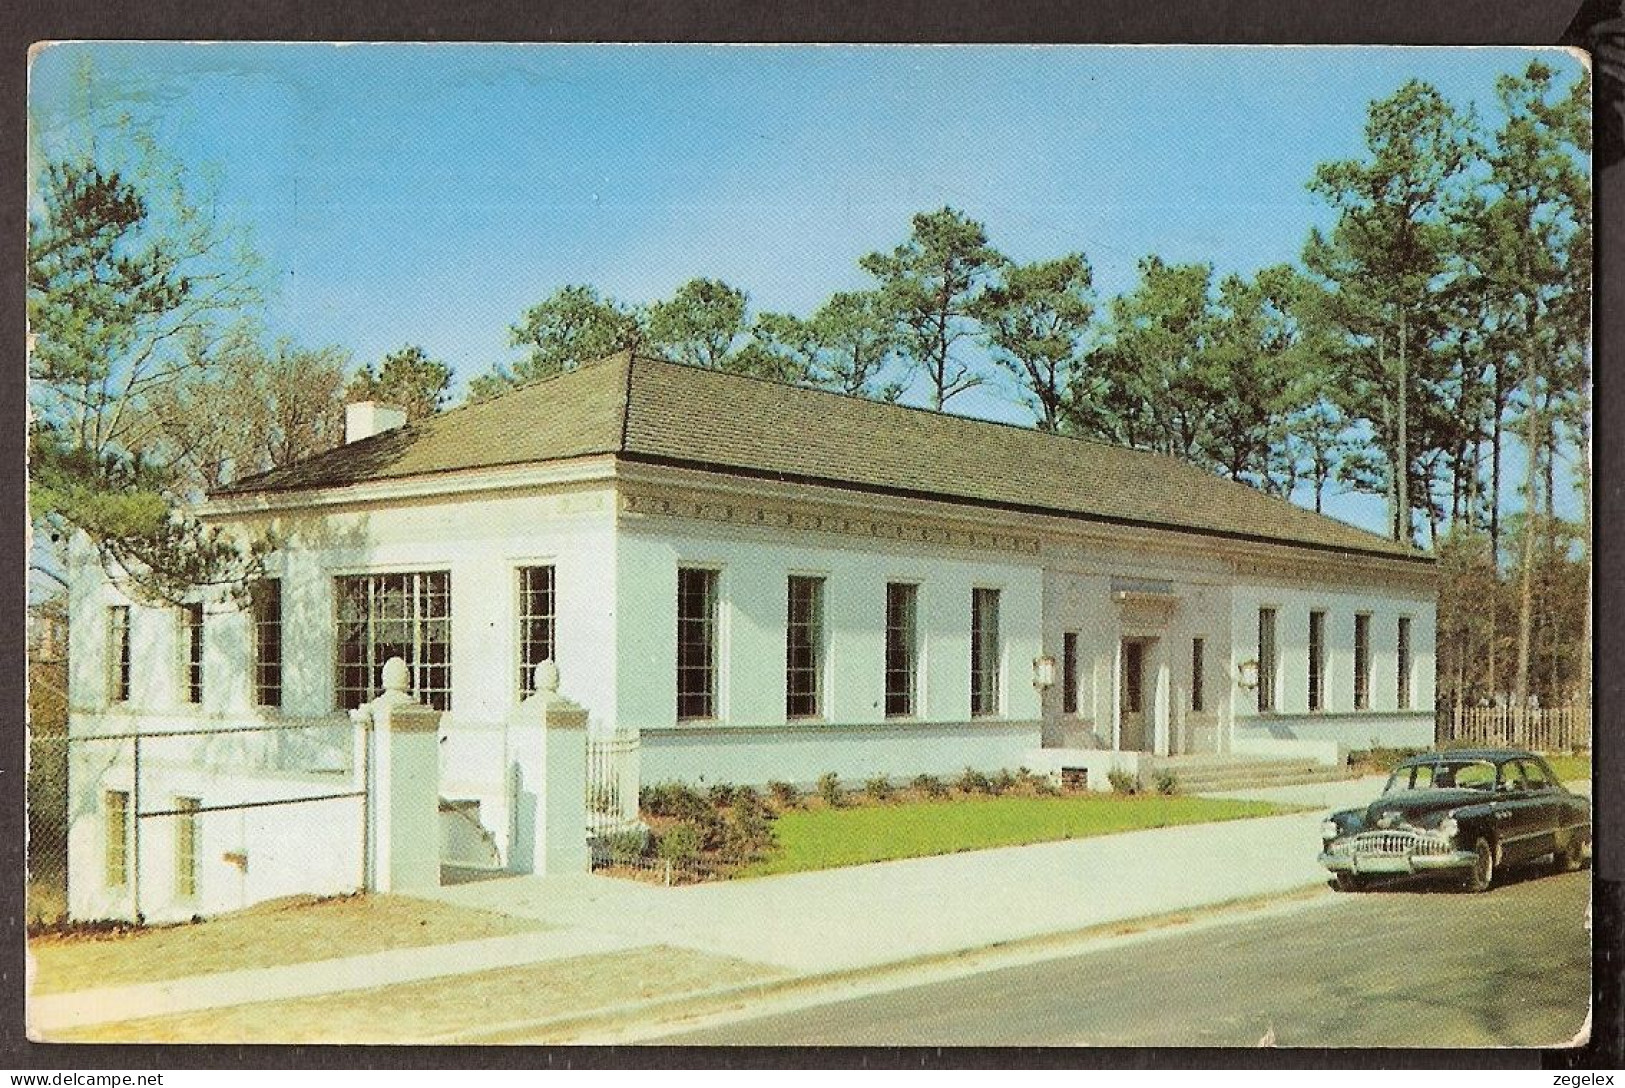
421,883,1331,1046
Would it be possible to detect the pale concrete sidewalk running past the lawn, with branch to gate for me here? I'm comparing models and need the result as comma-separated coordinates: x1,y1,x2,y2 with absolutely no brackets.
28,779,1381,1036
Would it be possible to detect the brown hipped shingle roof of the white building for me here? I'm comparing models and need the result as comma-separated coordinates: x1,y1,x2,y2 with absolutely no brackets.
216,354,1427,560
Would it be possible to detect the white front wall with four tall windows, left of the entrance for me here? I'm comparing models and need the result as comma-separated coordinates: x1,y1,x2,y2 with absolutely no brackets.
616,516,1042,784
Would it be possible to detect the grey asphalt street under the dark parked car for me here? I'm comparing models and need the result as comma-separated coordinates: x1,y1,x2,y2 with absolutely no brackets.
644,869,1591,1047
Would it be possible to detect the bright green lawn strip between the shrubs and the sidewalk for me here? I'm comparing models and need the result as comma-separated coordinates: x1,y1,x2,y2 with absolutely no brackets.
739,796,1300,877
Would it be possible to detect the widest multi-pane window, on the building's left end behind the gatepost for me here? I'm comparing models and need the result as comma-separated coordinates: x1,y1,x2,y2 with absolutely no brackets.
333,570,452,710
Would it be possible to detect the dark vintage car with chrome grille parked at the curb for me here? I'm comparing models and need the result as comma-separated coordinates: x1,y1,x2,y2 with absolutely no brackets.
1320,749,1591,892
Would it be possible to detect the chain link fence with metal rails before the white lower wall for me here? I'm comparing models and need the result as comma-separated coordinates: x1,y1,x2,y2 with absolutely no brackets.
28,718,367,927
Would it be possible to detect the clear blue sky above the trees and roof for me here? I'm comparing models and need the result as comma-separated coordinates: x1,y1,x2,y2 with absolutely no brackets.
29,44,1578,528
